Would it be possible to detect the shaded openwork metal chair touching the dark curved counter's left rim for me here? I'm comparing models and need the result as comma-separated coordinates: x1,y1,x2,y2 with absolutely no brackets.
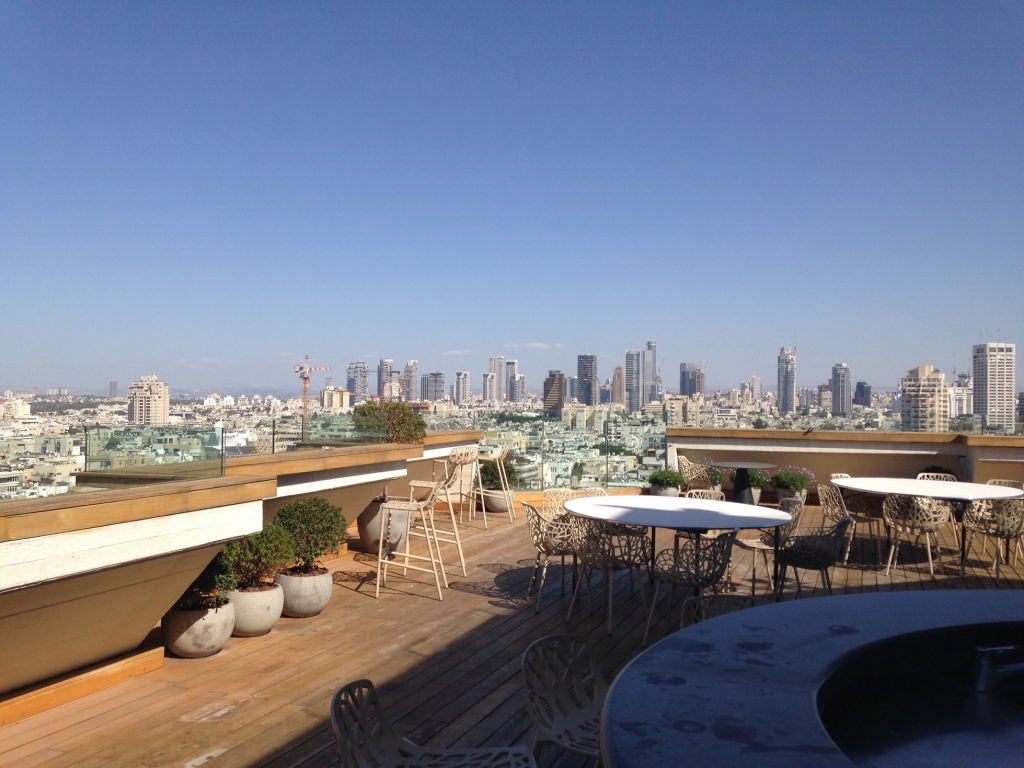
522,635,608,766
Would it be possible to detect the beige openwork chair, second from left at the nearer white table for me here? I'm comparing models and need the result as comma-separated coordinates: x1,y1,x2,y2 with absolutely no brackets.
565,516,651,635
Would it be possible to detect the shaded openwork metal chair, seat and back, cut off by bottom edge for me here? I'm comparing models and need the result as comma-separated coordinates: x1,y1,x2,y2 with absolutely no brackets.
331,680,537,768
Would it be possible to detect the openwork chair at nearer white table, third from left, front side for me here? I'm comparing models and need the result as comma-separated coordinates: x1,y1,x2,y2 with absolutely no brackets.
641,529,737,647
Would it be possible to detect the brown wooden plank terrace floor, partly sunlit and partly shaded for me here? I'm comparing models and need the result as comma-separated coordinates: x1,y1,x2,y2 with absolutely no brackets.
0,509,1024,768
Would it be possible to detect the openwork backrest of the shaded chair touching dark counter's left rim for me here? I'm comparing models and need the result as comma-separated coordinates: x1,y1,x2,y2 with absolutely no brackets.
522,635,608,732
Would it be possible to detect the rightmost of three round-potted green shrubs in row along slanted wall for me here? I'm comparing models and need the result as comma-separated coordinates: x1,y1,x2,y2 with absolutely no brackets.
274,496,345,618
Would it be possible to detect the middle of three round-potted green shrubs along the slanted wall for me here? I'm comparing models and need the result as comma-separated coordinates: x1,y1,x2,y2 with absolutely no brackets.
222,522,295,637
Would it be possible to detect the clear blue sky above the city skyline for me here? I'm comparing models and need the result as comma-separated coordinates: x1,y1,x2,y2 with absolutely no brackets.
0,1,1024,392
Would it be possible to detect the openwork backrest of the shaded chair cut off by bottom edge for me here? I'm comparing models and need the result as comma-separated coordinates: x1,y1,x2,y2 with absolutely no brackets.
331,680,400,768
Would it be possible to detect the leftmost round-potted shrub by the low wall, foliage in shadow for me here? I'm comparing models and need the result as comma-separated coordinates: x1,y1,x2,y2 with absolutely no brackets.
160,552,234,658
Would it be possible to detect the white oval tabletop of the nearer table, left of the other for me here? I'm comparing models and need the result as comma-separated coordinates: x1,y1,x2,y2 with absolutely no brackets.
565,496,793,530
